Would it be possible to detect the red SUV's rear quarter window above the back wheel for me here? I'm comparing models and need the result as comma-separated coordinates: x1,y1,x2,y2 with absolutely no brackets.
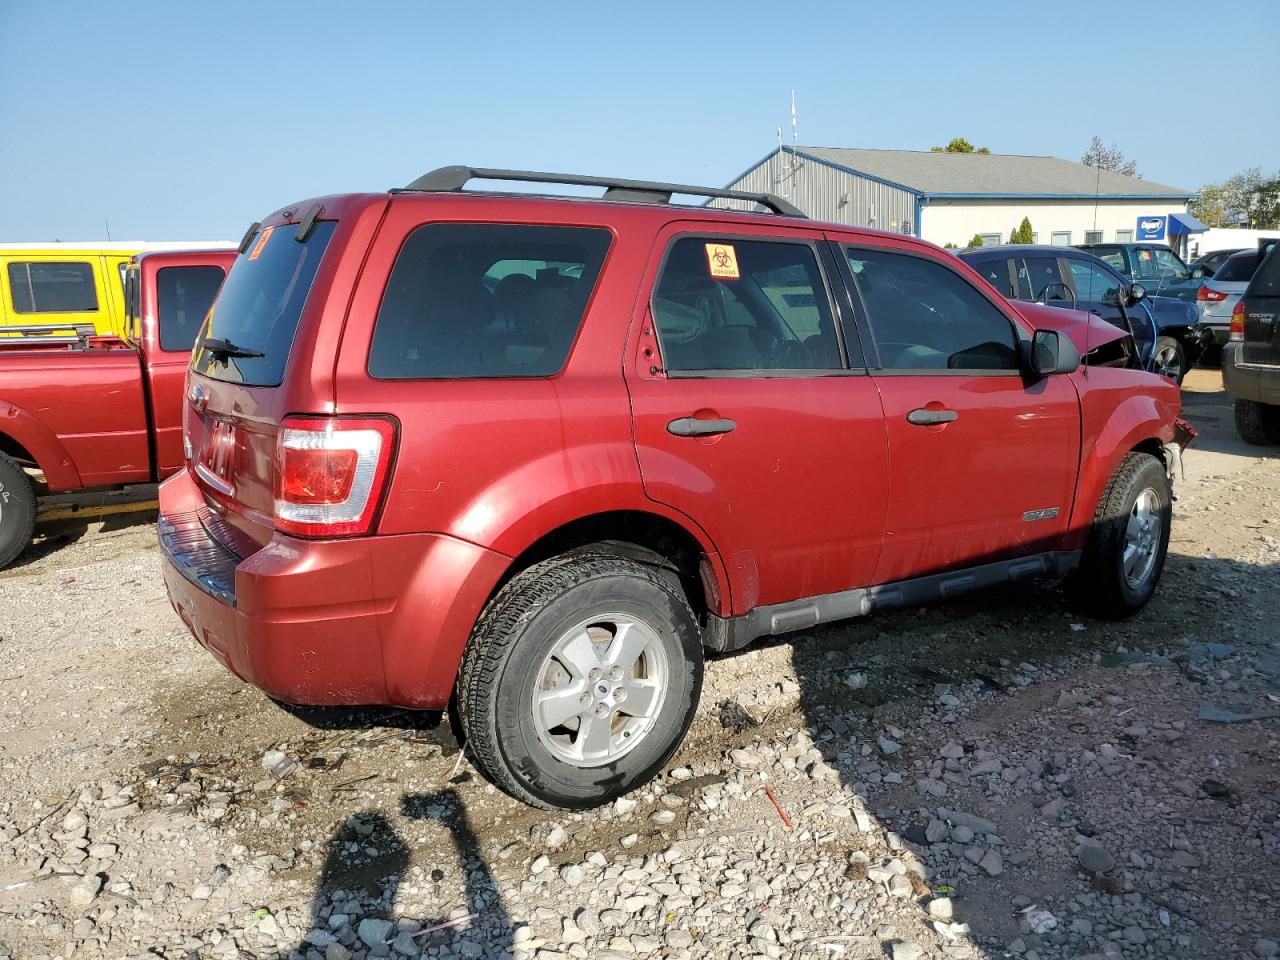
369,224,611,380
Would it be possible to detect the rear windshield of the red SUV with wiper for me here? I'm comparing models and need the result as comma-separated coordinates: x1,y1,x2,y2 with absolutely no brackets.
191,220,337,387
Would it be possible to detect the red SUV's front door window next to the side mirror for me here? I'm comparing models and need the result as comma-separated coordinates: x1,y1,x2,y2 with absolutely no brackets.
846,248,1018,370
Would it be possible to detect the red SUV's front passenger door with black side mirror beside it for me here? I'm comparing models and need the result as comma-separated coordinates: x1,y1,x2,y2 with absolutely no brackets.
841,243,1080,584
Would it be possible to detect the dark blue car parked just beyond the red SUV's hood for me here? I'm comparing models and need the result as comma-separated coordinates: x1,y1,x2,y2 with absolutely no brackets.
957,244,1201,384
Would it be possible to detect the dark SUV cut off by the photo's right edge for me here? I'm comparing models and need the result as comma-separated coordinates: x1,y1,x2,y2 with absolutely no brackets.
1222,241,1280,444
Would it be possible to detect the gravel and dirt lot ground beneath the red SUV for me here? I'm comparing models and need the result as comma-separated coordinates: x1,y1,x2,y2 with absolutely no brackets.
0,371,1280,960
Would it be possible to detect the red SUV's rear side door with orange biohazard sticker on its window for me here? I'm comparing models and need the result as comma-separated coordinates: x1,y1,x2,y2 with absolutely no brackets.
626,221,888,613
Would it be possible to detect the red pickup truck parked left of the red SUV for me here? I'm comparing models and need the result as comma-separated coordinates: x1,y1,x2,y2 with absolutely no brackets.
0,251,236,568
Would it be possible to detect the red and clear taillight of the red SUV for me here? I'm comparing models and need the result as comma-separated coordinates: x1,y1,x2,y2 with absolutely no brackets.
275,417,396,536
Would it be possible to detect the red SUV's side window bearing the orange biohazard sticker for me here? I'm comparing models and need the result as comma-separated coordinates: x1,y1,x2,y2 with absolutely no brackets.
653,237,842,371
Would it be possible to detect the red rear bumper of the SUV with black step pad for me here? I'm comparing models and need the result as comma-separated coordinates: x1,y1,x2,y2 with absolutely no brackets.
157,470,511,709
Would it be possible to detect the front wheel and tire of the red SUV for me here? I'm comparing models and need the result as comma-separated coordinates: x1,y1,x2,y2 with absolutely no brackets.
1075,452,1172,618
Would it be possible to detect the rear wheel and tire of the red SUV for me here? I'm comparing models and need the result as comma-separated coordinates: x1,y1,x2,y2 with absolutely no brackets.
454,552,703,810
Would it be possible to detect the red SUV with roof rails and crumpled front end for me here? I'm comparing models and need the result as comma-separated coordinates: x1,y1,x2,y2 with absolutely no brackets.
159,168,1179,808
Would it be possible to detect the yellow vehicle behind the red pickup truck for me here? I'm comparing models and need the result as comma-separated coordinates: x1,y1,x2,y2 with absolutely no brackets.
0,241,236,335
